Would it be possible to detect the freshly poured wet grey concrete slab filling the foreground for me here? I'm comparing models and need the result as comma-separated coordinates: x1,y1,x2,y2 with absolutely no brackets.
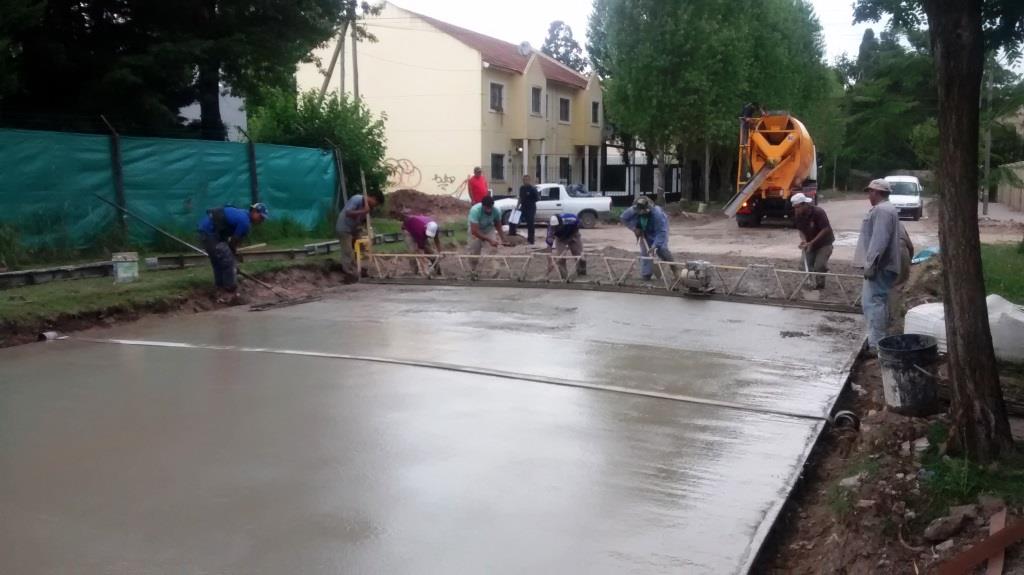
0,286,861,574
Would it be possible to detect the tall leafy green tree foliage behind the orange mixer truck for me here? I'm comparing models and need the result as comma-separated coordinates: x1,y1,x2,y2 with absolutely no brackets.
588,0,842,196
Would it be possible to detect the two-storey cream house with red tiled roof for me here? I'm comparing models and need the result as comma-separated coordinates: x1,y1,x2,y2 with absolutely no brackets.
297,2,604,195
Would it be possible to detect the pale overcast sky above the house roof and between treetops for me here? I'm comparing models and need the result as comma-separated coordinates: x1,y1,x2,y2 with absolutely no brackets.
394,0,881,62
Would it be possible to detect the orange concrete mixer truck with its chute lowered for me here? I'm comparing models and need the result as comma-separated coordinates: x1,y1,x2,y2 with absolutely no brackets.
725,112,817,227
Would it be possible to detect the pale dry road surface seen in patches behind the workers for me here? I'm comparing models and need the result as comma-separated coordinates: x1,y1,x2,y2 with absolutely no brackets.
583,198,1024,262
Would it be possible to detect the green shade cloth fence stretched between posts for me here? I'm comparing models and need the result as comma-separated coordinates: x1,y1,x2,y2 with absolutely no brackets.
0,130,338,249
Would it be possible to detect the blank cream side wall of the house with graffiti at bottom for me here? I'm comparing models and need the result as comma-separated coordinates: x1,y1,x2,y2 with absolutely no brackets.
296,3,487,193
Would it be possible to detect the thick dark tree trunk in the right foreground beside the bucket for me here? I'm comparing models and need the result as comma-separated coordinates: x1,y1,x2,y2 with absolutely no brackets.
925,0,1014,462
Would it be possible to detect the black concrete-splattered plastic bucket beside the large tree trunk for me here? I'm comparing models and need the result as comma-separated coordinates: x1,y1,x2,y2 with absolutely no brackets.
879,334,939,415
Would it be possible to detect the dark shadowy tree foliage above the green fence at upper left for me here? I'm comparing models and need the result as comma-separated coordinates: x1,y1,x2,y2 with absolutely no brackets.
0,0,357,138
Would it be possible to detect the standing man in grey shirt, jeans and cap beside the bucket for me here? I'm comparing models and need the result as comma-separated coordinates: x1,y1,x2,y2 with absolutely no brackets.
853,179,902,354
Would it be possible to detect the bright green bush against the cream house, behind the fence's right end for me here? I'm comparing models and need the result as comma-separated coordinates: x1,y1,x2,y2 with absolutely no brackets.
249,90,388,198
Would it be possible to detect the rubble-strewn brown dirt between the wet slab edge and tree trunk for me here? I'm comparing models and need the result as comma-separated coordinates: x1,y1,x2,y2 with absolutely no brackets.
755,351,1024,575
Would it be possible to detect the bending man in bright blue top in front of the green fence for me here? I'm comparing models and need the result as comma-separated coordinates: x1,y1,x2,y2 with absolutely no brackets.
199,204,270,294
